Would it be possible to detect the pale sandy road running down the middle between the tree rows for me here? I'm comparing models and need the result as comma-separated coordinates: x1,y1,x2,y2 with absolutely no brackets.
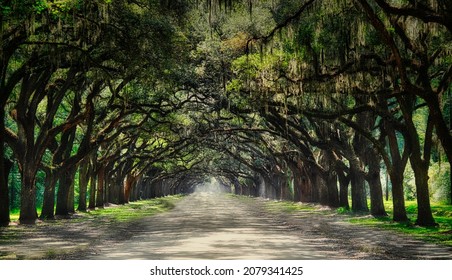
90,193,339,259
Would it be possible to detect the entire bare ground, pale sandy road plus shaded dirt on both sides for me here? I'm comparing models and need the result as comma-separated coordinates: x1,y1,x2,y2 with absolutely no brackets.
0,192,452,260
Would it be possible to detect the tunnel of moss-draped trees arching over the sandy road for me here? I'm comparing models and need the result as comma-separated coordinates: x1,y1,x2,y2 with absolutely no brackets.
0,0,452,226
